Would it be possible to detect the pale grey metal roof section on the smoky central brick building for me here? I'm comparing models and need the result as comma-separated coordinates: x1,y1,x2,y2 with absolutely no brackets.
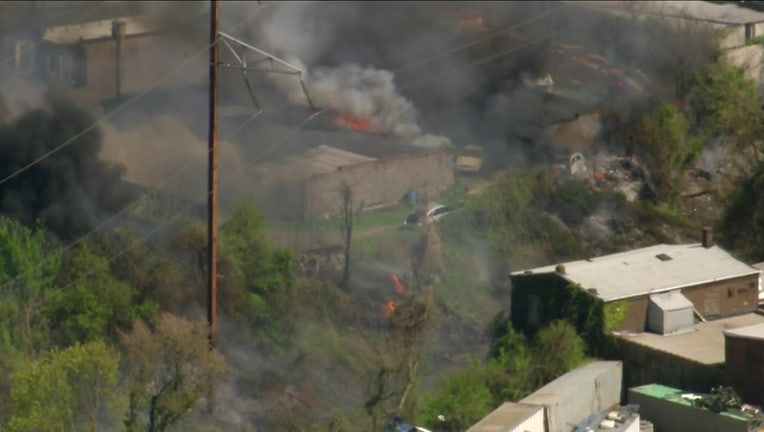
254,145,376,179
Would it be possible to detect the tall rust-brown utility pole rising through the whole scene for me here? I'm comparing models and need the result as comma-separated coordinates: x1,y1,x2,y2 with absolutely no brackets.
207,0,220,413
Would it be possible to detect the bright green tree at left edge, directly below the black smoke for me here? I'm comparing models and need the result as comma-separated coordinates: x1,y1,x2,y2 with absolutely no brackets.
0,216,61,354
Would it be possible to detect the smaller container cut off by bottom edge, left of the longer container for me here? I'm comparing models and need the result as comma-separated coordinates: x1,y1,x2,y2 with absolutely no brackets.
467,402,546,432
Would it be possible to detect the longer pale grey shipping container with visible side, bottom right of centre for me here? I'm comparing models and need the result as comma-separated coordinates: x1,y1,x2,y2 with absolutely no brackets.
520,361,623,432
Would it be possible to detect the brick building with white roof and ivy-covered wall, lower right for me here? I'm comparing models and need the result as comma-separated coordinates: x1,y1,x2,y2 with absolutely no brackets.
511,230,760,332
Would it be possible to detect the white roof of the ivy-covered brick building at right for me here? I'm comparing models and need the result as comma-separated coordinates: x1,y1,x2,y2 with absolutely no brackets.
512,244,759,301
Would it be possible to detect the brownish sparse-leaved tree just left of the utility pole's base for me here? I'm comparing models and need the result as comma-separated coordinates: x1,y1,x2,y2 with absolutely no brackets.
122,314,226,432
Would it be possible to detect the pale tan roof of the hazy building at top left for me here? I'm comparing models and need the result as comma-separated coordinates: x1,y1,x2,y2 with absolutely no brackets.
42,17,159,44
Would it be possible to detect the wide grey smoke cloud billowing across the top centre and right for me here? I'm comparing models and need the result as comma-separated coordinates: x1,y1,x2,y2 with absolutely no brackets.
223,2,713,164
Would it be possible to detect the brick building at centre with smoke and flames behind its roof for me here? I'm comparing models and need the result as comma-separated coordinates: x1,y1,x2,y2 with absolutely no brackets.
252,145,454,222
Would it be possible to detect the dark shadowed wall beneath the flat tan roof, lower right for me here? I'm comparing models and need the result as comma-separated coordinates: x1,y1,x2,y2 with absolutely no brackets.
614,337,724,394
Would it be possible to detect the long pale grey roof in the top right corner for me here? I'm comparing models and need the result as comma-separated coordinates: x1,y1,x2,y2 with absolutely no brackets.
573,1,764,25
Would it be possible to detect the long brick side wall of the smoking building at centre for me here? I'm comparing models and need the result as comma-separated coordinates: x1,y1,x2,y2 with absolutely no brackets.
305,151,454,217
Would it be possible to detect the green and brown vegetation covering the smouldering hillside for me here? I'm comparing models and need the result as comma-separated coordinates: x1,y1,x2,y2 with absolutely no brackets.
0,7,764,432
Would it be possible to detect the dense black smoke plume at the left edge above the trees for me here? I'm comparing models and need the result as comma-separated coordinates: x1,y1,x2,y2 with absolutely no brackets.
0,96,132,240
